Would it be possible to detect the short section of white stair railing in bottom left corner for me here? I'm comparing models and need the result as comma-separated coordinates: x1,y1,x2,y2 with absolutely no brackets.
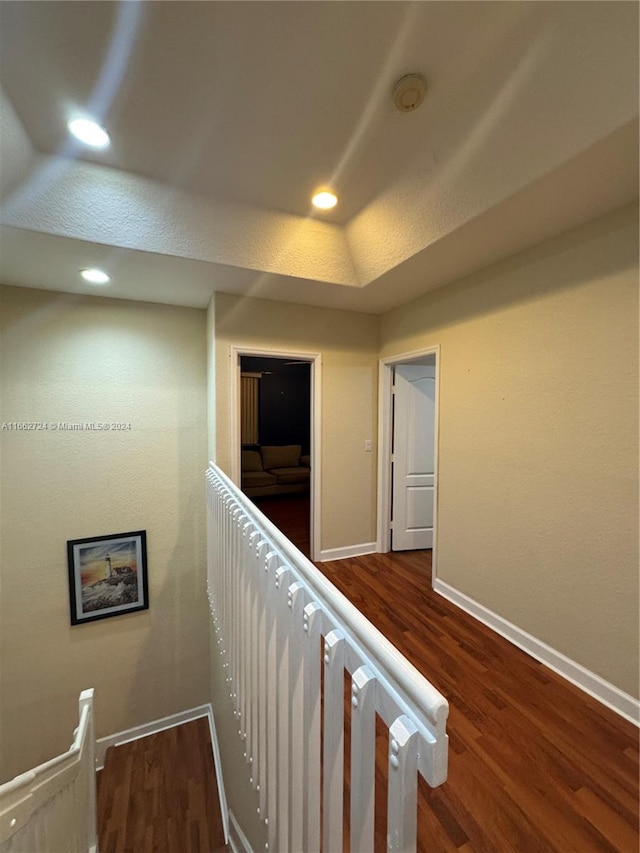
0,689,97,853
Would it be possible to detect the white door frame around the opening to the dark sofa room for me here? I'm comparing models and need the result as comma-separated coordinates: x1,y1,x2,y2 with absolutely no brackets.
229,344,322,560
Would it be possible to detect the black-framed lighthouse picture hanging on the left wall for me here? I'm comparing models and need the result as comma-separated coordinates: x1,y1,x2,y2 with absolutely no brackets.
67,530,149,625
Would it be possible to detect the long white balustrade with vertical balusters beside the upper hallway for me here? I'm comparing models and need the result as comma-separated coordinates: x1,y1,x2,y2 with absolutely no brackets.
207,464,448,853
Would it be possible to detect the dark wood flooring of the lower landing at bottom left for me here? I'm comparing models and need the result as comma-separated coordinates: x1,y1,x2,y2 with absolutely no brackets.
98,717,228,853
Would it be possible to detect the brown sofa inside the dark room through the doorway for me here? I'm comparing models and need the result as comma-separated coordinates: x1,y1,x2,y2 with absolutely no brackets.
240,444,311,498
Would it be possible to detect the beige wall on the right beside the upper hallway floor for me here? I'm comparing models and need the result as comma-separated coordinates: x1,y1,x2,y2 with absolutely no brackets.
381,209,638,696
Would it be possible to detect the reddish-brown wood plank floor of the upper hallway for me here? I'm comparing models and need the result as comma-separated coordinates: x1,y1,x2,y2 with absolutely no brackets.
317,551,639,853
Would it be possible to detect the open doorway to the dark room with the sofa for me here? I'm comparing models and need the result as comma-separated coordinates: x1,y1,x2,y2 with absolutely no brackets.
232,349,320,559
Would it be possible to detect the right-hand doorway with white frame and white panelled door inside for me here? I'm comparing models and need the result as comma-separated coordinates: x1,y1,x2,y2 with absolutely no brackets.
378,347,439,579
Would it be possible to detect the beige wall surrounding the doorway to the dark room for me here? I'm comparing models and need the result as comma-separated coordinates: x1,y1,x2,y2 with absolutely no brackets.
215,293,378,550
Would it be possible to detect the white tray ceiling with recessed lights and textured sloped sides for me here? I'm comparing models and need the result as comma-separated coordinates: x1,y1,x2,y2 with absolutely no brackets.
0,0,638,313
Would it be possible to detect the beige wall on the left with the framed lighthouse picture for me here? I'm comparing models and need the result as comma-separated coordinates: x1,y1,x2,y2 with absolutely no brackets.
0,288,208,779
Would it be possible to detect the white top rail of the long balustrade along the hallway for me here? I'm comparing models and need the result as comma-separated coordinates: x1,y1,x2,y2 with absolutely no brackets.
207,462,449,728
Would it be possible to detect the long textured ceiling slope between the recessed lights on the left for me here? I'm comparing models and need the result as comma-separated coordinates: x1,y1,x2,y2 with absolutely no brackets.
2,156,356,284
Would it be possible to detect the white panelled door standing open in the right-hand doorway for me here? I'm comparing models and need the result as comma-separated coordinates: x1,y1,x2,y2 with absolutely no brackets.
391,364,436,551
